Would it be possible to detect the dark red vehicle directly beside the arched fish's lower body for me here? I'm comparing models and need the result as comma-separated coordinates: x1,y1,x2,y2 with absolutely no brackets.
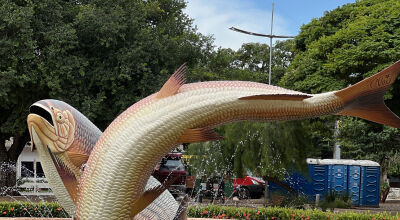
153,153,187,197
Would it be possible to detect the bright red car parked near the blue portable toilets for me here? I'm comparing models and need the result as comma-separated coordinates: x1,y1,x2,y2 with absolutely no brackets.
233,176,265,199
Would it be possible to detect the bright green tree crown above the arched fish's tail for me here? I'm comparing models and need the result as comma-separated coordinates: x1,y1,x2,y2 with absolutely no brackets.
281,0,400,98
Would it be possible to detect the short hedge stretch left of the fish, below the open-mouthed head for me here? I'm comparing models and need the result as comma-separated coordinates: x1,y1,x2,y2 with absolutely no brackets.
0,202,69,218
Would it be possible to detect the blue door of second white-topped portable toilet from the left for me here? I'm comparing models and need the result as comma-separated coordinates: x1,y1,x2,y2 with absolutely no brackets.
328,164,347,194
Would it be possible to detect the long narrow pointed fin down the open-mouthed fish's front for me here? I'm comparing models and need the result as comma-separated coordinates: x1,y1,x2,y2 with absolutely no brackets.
48,149,78,205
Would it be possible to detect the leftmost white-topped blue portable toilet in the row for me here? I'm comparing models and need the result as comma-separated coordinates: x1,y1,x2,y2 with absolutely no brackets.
307,158,329,198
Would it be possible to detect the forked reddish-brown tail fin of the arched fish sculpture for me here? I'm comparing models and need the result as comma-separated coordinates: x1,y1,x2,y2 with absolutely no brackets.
335,60,400,129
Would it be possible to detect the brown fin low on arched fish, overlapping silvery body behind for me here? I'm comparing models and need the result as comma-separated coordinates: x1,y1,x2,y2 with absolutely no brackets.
130,176,179,219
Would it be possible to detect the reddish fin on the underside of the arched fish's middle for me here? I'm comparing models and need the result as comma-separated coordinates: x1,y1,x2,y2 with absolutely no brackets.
177,127,223,143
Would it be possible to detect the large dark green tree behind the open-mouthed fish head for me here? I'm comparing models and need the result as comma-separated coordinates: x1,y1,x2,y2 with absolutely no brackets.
0,0,213,191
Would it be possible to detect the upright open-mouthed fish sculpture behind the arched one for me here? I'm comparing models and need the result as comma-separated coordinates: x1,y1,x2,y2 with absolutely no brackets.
27,99,178,219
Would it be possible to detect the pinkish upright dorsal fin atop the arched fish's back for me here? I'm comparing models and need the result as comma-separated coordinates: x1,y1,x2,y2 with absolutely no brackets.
155,64,186,99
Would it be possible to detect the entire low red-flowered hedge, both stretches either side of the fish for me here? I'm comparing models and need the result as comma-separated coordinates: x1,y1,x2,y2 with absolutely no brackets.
0,202,400,220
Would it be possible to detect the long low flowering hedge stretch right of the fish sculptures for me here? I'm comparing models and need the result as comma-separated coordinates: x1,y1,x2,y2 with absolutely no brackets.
188,205,400,220
